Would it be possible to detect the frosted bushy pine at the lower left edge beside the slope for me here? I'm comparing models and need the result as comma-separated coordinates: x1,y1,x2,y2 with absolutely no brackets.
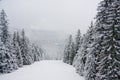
0,41,18,74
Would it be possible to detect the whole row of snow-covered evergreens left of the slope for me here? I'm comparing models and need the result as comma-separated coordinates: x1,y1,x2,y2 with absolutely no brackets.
0,10,44,74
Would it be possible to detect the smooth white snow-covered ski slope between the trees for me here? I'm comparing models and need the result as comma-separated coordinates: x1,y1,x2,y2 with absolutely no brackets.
0,60,84,80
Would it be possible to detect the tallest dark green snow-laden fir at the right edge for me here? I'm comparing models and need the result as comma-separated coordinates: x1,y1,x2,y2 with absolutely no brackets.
87,0,120,80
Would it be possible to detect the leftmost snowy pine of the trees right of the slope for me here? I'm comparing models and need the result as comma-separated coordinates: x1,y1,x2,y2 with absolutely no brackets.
63,35,74,64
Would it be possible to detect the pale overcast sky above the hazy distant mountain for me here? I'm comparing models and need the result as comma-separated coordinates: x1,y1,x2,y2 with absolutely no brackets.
0,0,100,33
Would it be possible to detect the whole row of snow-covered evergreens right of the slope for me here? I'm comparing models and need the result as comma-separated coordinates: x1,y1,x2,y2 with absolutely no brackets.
63,0,120,80
